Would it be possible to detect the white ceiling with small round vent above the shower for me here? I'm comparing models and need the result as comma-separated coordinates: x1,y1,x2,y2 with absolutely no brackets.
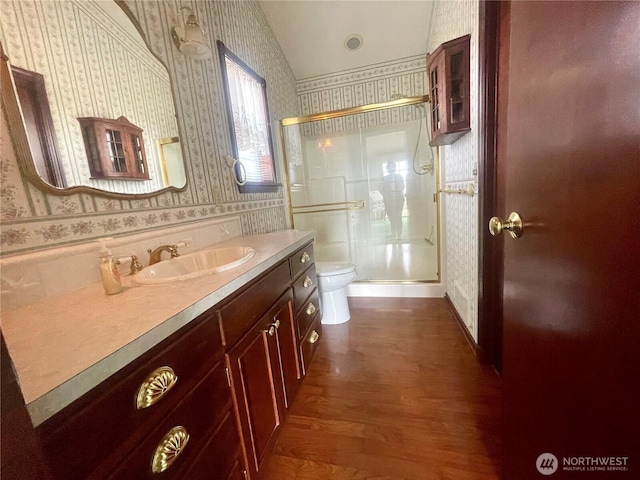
260,0,437,80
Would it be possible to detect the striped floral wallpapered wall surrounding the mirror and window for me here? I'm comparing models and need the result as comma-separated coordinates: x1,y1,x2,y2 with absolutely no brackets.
0,0,298,255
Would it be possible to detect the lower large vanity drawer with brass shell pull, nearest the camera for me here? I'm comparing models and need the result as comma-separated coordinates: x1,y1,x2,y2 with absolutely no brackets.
108,364,234,480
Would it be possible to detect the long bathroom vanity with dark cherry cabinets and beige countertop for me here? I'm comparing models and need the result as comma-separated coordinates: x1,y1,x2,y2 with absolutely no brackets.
3,231,322,480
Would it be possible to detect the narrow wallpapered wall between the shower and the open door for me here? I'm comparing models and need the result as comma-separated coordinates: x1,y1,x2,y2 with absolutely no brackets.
428,0,479,341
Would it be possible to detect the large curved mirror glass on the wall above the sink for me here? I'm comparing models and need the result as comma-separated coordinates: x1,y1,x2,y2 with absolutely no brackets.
0,0,187,197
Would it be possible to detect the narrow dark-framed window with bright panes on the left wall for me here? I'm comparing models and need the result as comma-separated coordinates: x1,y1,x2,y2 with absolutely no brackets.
218,41,279,193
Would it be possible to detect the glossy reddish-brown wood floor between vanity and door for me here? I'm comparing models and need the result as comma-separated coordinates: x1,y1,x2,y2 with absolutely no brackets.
261,298,501,480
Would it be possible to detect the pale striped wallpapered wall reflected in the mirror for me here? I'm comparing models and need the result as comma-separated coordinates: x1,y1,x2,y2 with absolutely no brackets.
0,1,182,193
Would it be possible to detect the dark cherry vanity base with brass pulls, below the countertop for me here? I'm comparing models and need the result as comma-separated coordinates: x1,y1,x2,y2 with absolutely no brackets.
36,240,321,480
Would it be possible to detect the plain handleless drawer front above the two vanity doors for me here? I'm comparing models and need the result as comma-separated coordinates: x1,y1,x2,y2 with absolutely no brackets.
218,261,290,347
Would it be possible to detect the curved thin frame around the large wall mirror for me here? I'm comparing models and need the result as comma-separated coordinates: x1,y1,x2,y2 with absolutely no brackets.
0,0,189,200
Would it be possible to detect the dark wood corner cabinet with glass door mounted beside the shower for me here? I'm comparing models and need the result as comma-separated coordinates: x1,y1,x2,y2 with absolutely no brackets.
427,35,471,147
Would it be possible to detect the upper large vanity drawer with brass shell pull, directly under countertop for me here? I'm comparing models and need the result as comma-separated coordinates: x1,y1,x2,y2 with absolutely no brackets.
37,313,226,480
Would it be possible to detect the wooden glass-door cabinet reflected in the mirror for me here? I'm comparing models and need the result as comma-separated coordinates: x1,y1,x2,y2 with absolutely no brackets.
78,117,149,180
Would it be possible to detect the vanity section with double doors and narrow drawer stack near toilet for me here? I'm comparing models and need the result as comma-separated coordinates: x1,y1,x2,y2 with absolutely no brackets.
220,244,320,479
